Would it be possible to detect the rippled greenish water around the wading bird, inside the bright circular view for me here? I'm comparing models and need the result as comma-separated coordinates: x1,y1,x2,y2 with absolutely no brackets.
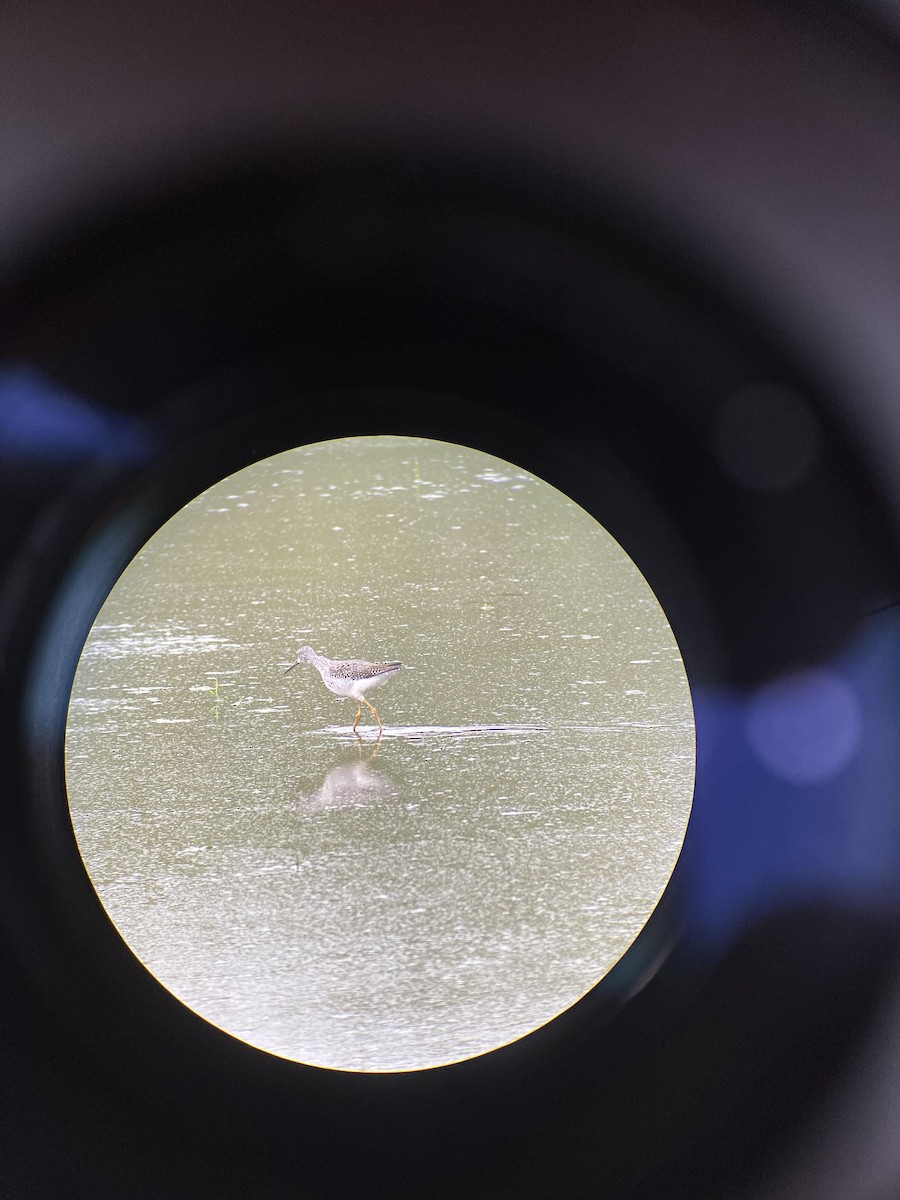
66,437,694,1070
